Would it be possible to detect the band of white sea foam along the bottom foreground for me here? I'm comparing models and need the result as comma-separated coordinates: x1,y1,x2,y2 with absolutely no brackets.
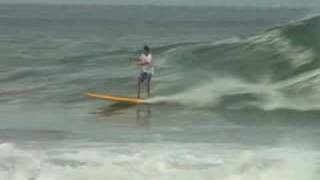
0,143,319,180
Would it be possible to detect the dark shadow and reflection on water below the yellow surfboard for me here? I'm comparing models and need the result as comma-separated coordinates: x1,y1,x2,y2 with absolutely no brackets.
91,103,152,127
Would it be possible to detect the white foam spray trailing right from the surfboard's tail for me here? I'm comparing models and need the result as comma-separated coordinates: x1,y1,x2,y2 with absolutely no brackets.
148,70,320,111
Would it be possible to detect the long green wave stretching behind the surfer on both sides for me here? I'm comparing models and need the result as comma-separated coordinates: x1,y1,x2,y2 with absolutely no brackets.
0,16,320,111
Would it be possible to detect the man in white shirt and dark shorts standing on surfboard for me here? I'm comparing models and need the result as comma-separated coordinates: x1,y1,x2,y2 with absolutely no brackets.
137,46,154,98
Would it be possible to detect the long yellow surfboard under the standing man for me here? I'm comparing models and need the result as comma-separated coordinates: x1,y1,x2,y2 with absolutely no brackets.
84,93,145,104
